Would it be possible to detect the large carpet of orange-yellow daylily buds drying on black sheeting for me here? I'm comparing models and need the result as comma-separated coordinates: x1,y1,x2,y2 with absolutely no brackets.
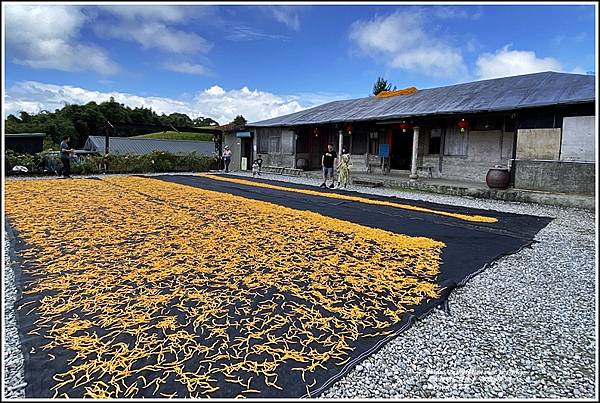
5,177,444,398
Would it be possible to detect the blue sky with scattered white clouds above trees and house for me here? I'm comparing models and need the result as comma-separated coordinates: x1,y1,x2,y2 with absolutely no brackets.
2,2,596,124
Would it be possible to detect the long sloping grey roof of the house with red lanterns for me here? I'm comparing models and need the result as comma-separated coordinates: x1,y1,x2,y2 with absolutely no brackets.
247,71,596,127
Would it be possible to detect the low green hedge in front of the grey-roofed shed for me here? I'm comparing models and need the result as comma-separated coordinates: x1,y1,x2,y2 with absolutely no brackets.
4,150,217,175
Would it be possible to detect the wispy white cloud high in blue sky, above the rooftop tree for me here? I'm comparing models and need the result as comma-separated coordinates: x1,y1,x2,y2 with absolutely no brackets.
349,11,467,77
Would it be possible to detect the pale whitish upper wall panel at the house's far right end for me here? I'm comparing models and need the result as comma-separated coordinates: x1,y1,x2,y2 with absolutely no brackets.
560,116,596,162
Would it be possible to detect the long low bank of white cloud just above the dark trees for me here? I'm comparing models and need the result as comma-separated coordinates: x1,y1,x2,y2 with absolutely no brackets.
4,81,339,124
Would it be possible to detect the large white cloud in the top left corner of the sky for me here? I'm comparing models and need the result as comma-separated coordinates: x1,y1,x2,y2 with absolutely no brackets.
4,4,119,74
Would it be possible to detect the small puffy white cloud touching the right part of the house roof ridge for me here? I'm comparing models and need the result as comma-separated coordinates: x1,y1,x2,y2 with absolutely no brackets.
475,45,564,78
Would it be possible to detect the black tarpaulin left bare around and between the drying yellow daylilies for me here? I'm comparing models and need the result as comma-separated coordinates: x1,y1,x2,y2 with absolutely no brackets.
11,176,550,398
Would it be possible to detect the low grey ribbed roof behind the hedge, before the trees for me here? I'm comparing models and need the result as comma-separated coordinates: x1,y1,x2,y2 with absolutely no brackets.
84,136,215,155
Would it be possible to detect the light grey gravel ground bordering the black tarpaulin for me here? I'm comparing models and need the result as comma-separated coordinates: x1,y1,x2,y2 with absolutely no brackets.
4,173,598,399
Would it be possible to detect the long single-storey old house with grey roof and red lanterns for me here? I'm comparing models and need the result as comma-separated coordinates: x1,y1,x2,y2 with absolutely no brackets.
247,72,596,194
